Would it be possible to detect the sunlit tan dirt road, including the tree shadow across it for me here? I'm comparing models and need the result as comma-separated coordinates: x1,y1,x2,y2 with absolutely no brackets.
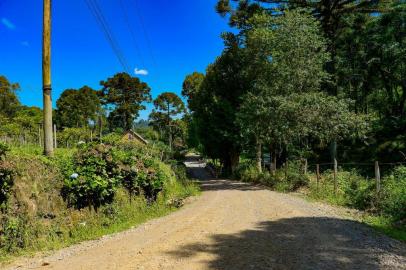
6,158,406,270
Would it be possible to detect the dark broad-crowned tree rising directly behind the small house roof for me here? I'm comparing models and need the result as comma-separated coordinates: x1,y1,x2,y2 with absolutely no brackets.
99,73,151,130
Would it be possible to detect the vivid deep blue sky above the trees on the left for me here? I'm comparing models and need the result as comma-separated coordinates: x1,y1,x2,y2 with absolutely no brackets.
0,0,229,119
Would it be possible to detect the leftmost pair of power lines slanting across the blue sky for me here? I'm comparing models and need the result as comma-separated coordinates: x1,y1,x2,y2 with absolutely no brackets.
85,0,130,74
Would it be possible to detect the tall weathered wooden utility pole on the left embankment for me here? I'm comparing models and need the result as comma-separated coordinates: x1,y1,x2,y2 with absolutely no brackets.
42,0,54,156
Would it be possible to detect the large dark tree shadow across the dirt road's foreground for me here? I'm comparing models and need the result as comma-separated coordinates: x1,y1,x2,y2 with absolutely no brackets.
169,217,406,270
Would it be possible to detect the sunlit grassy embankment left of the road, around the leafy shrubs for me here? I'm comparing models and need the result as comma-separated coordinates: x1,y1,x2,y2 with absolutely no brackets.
0,144,199,262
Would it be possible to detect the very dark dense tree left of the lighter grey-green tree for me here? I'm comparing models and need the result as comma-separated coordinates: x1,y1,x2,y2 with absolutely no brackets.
189,41,252,174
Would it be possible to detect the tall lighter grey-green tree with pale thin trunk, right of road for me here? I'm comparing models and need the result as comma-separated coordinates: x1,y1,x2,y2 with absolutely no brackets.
237,10,329,170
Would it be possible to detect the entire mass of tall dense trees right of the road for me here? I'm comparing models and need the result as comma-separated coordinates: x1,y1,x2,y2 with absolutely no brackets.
183,0,406,174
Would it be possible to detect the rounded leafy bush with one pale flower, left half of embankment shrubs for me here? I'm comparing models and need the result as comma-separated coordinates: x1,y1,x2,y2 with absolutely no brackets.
62,144,120,209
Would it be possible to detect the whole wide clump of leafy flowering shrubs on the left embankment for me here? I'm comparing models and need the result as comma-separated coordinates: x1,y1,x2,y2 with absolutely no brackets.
62,144,168,209
